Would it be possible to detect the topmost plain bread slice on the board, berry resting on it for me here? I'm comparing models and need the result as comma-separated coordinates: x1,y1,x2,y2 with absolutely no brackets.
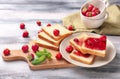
42,24,72,40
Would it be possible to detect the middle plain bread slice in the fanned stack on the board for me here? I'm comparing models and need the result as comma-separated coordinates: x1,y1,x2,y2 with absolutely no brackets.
38,31,62,46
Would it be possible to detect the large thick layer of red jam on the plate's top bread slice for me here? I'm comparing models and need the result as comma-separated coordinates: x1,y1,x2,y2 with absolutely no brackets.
85,36,106,50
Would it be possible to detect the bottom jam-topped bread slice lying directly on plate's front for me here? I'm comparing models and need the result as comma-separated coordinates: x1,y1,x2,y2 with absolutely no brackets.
70,50,95,64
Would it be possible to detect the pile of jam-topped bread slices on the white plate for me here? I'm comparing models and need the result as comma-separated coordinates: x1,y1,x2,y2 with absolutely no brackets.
70,33,107,64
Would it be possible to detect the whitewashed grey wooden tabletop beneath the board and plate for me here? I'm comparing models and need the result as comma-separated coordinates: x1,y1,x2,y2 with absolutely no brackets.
0,0,120,79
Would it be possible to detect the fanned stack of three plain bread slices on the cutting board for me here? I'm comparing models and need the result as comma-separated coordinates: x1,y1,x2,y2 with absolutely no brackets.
35,24,72,50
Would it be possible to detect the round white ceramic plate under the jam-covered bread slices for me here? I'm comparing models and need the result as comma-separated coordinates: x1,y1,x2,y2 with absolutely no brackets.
60,32,116,68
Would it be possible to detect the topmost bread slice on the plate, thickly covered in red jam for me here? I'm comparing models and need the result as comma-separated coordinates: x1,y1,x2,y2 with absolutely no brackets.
81,35,107,57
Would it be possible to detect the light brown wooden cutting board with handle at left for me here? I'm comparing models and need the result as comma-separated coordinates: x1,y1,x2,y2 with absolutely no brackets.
2,41,75,70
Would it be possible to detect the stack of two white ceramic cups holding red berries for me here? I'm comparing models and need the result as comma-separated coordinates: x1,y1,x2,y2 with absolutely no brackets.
80,0,108,28
